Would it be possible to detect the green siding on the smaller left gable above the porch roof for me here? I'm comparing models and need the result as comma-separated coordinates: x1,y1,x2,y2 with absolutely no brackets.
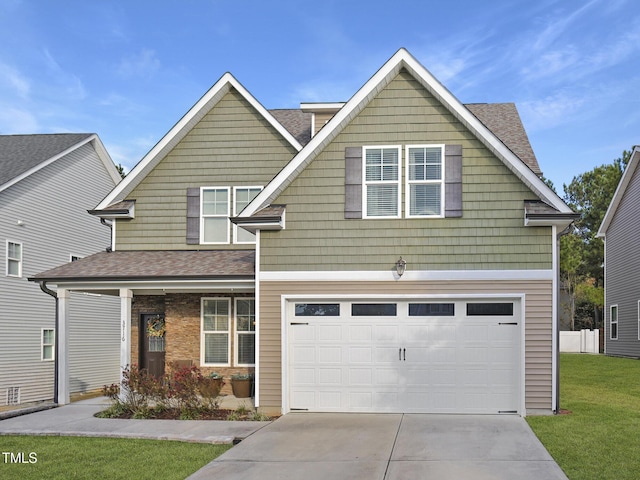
116,90,296,250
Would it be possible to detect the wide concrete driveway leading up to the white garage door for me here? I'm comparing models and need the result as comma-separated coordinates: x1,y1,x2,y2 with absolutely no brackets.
189,413,567,480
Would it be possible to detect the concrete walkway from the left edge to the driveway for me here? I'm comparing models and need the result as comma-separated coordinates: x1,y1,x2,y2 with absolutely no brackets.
0,396,271,443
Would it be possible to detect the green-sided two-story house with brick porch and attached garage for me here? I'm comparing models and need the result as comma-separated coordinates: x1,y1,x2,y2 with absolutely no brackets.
34,49,575,415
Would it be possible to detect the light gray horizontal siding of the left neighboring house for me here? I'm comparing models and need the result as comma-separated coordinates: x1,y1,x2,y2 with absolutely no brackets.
0,144,119,405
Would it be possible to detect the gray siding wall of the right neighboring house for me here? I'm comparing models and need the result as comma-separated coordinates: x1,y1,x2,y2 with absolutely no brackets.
605,165,640,357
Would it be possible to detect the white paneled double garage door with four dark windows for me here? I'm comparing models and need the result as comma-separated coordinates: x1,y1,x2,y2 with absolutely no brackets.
286,299,522,414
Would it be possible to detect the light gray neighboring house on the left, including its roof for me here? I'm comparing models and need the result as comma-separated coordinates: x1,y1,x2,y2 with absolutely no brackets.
0,133,120,406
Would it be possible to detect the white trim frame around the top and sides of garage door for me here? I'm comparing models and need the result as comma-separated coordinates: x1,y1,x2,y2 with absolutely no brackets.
280,293,527,417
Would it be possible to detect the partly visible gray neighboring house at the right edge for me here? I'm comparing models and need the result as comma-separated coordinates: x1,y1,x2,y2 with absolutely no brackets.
598,146,640,358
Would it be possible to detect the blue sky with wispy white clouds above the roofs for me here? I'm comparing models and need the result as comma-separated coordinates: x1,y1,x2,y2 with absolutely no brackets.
0,0,640,191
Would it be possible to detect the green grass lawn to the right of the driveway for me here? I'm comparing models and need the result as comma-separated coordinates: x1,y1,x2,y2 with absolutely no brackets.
527,354,640,480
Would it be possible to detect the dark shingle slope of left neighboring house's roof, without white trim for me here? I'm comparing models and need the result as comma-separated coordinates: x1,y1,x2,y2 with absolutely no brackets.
0,133,92,185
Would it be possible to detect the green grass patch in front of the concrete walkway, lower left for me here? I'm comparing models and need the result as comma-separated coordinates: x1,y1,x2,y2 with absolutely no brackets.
0,435,231,480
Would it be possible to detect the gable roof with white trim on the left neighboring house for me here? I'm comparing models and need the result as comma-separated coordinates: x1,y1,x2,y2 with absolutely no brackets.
0,133,120,192
